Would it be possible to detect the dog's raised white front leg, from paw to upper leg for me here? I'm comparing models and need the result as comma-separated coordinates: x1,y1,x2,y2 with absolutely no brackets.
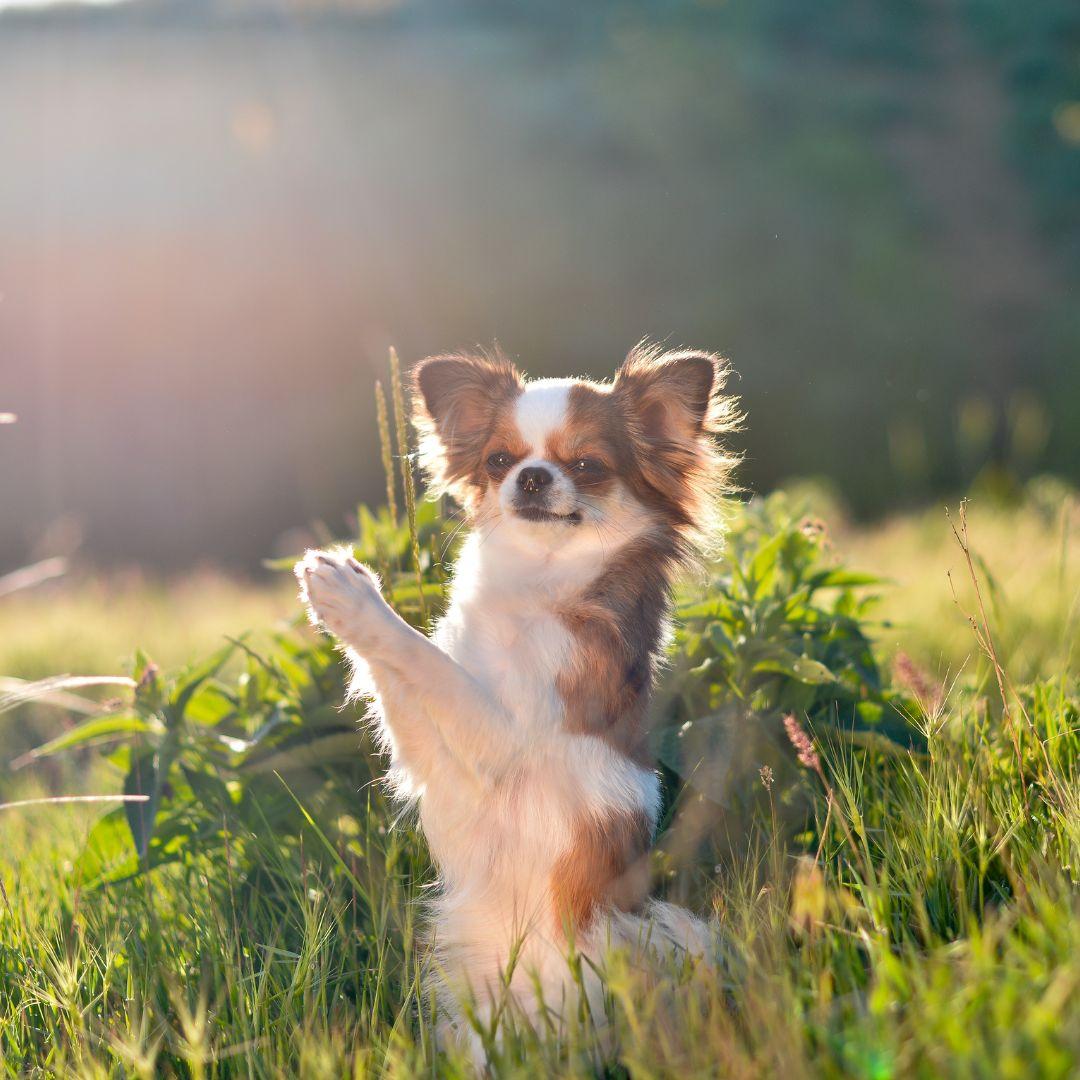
295,551,519,782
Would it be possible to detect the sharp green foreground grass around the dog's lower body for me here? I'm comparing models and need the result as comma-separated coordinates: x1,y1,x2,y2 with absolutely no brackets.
0,669,1080,1077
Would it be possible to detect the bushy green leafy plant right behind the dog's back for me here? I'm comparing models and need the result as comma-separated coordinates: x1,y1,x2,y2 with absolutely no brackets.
654,492,922,881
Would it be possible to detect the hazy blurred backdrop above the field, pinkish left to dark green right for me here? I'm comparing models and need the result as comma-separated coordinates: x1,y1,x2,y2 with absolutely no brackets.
0,0,1080,573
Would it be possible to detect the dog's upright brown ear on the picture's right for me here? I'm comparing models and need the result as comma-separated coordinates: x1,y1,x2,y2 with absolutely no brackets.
612,349,725,447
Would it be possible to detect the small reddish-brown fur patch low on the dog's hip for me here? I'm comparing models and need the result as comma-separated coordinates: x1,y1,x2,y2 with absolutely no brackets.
551,810,651,928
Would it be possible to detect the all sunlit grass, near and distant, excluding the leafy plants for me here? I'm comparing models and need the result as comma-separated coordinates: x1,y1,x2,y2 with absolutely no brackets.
0,497,1080,1078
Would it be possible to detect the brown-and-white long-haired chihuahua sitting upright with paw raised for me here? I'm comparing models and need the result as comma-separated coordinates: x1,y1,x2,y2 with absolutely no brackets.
296,345,735,1059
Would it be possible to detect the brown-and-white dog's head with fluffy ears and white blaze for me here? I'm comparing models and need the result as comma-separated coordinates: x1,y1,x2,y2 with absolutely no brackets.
414,346,733,546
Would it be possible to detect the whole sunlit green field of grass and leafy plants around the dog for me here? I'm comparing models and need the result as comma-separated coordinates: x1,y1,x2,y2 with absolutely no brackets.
0,482,1080,1078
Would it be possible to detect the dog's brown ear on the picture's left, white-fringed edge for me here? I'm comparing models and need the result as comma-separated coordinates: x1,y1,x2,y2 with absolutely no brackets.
413,353,522,500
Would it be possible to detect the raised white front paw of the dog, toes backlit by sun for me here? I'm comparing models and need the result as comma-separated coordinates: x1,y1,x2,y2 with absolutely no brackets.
293,548,386,645
